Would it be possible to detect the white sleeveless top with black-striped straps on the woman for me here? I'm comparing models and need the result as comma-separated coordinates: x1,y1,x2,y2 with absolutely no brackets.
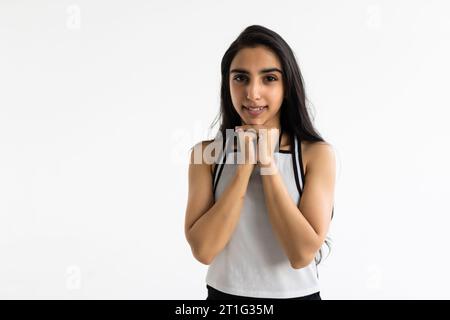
206,131,320,298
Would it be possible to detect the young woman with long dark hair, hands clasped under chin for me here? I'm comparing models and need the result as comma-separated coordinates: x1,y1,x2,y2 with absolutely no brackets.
185,25,335,300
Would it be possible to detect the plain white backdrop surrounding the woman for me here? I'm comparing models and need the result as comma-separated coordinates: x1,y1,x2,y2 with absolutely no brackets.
0,0,450,299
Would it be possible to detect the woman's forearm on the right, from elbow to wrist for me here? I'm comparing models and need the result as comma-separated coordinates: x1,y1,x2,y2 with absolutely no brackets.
261,164,320,267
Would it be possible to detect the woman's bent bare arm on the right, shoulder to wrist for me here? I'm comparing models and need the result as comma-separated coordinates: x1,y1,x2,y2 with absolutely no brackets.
261,144,335,269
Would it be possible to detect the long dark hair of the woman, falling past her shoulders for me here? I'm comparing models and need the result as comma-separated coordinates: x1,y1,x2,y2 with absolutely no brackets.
211,25,334,264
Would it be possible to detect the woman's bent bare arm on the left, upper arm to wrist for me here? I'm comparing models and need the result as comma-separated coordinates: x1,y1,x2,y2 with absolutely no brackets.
185,140,253,264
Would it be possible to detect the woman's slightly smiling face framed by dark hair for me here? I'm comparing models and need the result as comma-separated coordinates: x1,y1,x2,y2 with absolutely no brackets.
230,46,284,128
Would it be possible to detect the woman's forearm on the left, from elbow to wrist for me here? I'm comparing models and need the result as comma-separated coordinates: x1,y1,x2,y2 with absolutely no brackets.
189,169,251,264
